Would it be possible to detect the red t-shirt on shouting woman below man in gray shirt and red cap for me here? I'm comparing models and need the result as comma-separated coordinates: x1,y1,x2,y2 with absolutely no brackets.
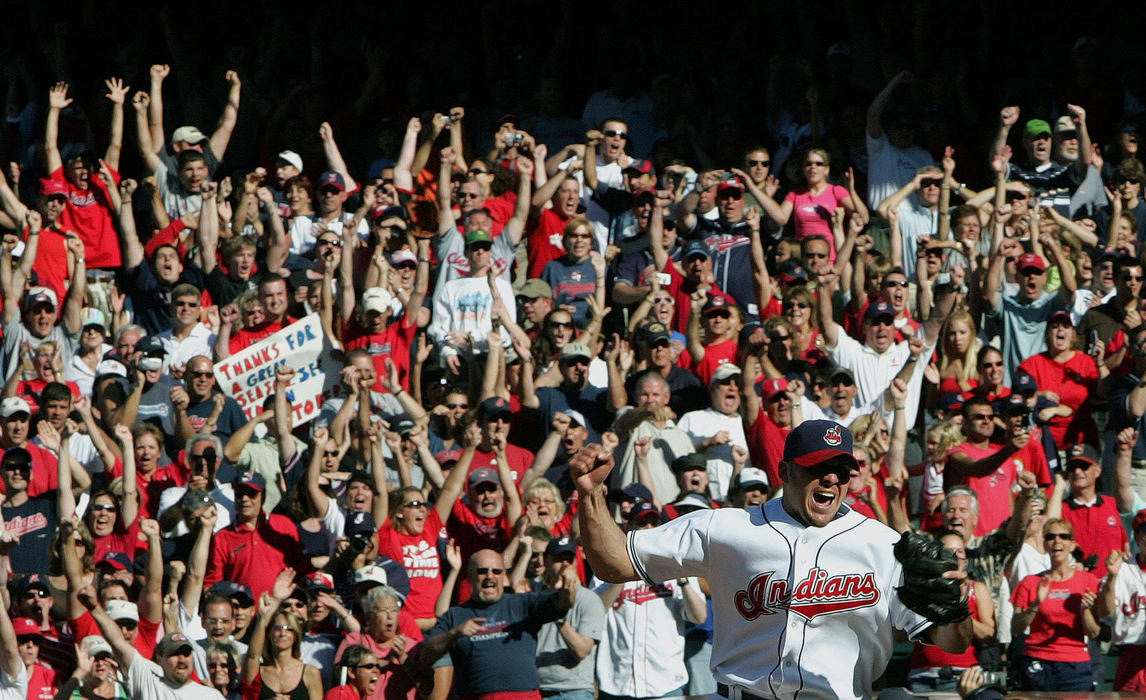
1019,352,1098,449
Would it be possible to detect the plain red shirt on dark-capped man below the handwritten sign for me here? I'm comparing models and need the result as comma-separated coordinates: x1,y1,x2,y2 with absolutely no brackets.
203,513,312,599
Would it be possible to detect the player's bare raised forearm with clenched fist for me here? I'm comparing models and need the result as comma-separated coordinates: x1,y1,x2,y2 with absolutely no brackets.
570,445,637,583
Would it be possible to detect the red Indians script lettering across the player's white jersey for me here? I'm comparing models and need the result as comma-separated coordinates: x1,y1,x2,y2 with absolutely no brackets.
733,567,879,620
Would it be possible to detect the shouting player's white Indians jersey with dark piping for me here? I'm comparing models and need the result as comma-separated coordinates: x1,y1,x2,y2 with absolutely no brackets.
628,498,931,698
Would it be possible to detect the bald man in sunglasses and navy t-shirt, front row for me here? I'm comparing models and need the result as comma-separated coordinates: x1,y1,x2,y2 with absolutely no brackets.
418,549,580,699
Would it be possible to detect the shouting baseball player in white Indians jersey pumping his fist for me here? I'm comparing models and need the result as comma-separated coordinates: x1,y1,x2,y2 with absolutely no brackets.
570,420,972,700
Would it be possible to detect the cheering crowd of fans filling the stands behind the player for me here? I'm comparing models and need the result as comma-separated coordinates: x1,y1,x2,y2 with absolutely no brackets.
0,6,1146,700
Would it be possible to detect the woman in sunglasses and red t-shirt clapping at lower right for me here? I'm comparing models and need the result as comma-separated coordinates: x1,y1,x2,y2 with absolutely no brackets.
1011,518,1100,691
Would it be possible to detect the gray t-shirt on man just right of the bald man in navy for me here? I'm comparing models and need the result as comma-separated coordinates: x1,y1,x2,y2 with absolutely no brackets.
537,585,605,691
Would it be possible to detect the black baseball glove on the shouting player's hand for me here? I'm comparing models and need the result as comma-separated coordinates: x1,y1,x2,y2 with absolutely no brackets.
894,533,971,624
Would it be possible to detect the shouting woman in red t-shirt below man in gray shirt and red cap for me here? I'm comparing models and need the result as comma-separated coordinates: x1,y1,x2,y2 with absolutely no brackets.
1019,312,1109,448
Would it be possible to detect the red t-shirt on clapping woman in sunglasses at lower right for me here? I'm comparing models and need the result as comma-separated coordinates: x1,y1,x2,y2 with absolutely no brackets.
1011,569,1098,663
